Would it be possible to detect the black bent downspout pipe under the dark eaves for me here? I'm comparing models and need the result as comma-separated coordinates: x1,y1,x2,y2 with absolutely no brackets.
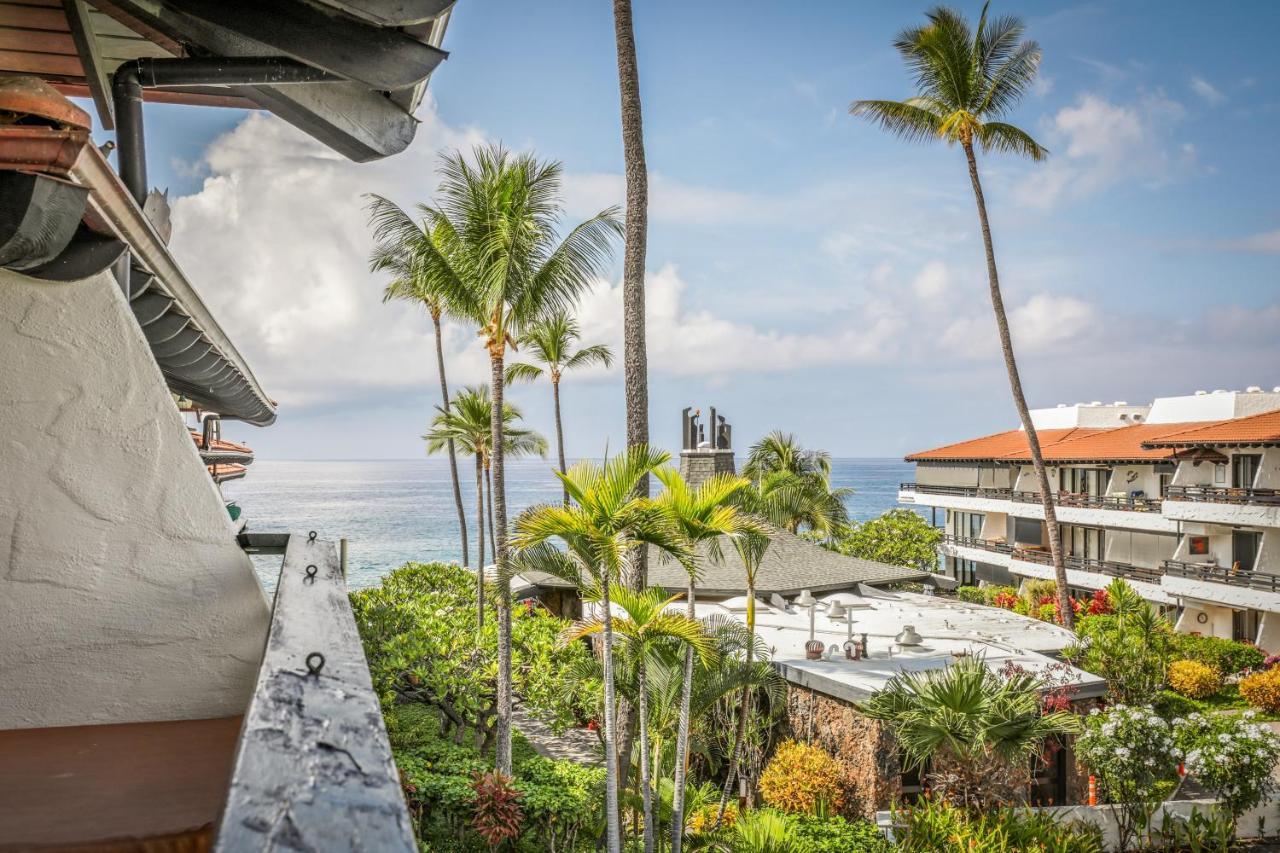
111,56,342,207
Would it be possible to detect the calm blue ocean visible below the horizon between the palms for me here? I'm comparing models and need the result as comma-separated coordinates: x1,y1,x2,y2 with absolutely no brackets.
223,459,915,590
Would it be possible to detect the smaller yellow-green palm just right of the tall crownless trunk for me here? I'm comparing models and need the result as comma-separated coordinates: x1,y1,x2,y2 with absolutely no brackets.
657,467,764,853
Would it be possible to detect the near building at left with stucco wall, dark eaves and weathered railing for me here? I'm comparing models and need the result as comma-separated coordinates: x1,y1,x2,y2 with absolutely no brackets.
0,0,452,852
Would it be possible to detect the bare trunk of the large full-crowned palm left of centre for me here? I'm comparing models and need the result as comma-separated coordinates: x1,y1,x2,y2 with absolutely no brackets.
489,343,511,776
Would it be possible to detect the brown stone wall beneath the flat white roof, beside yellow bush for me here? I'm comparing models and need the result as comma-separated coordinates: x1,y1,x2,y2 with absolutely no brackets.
786,684,902,820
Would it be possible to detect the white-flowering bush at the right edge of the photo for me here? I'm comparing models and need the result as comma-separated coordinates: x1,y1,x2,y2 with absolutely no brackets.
1174,711,1280,818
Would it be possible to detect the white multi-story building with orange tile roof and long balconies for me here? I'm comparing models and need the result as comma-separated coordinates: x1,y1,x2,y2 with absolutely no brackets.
899,388,1280,649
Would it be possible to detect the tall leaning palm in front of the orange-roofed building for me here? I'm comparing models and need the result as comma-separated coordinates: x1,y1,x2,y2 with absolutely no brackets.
849,3,1074,628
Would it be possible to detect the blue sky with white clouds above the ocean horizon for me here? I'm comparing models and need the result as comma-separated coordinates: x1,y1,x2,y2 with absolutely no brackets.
122,0,1280,459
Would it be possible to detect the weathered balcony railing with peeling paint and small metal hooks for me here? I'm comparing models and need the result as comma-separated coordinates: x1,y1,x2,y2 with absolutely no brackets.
215,533,417,853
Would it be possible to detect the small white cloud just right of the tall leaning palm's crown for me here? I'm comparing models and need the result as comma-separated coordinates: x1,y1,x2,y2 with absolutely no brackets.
1012,91,1197,207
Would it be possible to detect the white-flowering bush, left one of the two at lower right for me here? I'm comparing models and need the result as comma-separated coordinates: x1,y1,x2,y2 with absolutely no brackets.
1075,704,1181,849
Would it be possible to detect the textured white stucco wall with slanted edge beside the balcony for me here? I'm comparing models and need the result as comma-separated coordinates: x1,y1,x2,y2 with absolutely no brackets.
0,263,269,729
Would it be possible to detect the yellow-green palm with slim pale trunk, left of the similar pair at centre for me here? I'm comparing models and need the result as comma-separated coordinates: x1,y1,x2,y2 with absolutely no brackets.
508,446,692,853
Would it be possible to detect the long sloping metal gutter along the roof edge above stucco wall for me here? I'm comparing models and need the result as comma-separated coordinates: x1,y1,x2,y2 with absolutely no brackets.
72,145,275,427
